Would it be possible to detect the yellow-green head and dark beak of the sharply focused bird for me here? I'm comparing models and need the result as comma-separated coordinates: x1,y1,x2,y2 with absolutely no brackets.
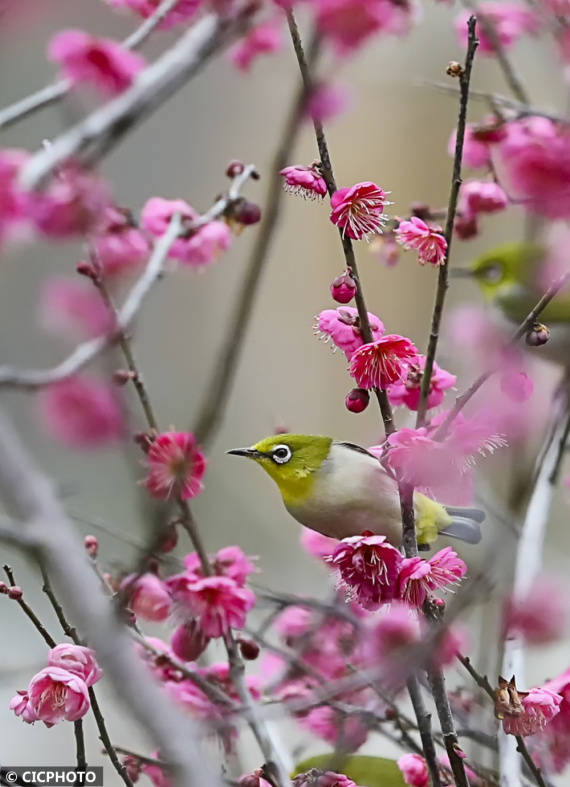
228,434,332,503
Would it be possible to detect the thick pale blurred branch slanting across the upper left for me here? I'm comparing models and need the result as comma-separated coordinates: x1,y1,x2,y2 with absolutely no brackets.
20,8,251,189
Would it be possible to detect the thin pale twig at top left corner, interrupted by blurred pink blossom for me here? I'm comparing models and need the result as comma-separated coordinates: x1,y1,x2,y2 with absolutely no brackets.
0,0,180,129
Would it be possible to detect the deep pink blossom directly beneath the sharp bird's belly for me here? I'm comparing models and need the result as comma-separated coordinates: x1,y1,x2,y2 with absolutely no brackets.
330,535,402,609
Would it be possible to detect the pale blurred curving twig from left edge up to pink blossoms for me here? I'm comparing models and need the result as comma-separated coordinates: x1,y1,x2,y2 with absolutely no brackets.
0,214,181,389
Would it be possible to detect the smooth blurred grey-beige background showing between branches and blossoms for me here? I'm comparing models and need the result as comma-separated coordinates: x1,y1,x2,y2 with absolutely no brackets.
0,0,570,785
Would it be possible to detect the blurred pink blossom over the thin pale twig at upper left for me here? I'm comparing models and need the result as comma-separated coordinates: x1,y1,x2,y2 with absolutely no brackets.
49,30,146,95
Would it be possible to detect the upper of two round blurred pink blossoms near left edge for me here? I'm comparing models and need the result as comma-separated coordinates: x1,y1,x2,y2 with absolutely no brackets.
40,276,113,342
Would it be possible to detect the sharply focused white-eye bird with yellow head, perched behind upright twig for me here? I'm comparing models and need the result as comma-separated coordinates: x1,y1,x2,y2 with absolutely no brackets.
227,434,485,548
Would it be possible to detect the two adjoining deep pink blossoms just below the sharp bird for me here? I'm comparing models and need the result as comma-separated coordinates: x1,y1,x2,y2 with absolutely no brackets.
329,534,467,610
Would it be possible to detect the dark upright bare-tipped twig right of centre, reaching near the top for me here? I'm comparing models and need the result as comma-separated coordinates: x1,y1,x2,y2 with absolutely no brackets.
416,16,479,428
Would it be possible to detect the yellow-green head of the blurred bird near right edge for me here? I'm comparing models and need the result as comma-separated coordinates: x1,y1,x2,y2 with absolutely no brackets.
468,243,543,301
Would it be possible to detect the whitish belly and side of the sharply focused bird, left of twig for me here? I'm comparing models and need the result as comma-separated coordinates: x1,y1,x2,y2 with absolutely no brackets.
285,445,402,545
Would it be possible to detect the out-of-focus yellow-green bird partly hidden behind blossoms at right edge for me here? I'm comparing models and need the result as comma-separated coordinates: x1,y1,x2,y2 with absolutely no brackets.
466,243,570,366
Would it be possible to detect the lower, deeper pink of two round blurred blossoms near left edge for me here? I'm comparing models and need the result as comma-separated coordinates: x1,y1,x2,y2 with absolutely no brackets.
38,375,124,448
